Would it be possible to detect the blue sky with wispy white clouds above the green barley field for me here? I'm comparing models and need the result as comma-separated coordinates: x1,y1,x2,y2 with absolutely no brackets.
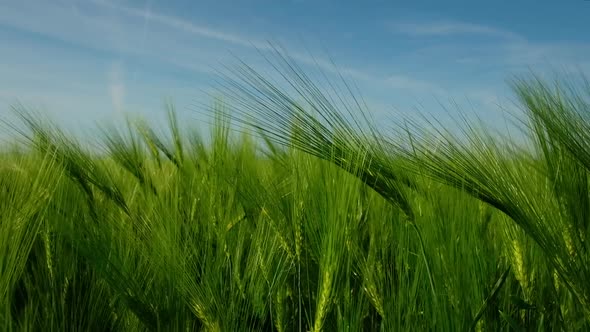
0,0,590,136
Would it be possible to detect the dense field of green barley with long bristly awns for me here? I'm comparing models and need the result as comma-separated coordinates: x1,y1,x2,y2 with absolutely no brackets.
0,57,590,331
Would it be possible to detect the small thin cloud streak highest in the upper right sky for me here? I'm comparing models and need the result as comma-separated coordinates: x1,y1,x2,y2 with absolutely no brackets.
390,21,523,40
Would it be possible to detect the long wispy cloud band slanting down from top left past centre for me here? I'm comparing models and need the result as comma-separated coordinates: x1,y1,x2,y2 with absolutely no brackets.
0,0,454,100
